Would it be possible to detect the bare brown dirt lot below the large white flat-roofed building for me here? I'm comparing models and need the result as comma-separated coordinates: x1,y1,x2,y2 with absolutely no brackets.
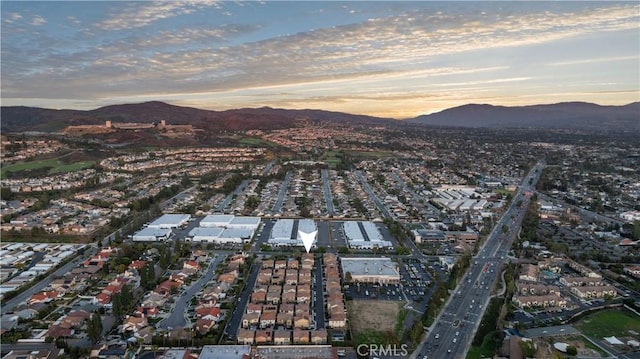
347,300,403,333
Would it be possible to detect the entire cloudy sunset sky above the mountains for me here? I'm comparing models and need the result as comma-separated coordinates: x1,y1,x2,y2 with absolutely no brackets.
0,1,640,119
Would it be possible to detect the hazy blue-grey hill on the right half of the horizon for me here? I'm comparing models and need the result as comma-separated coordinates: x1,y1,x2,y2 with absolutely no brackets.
406,102,640,131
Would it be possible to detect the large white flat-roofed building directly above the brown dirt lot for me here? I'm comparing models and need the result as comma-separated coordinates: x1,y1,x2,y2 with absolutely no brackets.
340,258,400,283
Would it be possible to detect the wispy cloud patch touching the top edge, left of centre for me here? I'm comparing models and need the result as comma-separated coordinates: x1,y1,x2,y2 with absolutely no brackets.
96,1,218,30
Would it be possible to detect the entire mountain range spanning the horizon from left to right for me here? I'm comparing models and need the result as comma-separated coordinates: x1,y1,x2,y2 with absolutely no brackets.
0,101,640,133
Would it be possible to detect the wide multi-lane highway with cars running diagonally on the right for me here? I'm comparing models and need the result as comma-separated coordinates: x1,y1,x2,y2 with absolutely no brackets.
411,162,544,358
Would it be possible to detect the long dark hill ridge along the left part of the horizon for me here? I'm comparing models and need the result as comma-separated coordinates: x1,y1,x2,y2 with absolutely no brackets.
1,101,395,132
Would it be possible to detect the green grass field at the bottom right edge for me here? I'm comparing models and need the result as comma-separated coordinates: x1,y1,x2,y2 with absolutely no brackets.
576,310,640,339
